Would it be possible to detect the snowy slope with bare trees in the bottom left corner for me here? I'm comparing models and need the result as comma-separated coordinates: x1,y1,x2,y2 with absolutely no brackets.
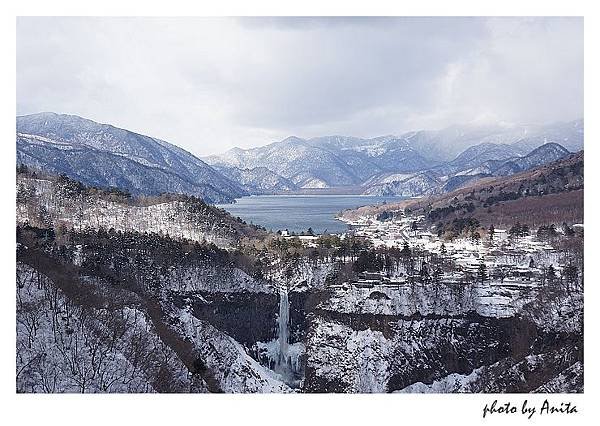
16,263,196,393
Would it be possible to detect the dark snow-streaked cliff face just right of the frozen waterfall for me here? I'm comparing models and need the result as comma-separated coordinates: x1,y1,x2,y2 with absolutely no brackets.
306,315,515,392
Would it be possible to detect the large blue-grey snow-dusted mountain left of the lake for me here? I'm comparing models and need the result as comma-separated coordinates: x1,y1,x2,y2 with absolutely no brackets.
17,113,247,202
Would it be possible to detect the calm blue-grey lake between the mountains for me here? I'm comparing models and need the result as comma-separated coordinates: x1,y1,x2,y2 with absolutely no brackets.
217,195,403,234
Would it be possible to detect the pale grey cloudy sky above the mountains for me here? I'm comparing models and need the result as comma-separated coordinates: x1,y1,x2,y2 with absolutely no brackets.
17,18,583,155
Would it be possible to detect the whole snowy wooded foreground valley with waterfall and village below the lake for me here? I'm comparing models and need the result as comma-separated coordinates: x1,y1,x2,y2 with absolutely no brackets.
16,153,583,392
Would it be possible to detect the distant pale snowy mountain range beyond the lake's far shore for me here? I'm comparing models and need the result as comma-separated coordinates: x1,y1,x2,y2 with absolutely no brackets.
205,120,583,195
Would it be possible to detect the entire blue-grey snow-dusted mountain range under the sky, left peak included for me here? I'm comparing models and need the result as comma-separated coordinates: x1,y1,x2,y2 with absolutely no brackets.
17,113,583,202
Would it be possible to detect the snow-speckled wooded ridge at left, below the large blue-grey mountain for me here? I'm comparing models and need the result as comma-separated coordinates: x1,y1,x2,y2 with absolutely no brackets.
16,167,263,247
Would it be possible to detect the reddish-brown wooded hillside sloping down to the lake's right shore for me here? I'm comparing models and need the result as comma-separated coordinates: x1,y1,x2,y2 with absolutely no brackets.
342,151,583,230
